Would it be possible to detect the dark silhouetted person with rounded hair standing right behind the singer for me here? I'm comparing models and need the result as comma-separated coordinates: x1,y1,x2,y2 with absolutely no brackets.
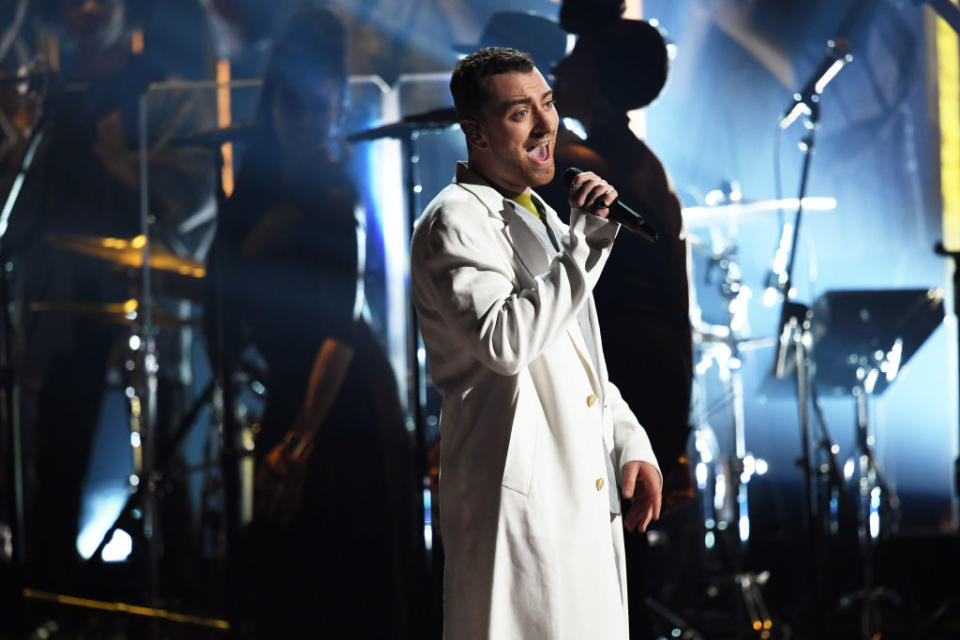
547,16,693,637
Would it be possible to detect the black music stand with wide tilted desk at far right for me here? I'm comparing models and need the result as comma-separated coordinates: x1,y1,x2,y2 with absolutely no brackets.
774,289,944,638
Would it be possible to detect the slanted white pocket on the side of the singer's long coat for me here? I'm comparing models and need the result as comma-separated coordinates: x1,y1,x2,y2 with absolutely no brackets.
501,369,546,496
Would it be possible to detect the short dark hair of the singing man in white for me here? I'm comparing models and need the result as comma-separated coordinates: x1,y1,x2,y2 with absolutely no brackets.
450,47,534,118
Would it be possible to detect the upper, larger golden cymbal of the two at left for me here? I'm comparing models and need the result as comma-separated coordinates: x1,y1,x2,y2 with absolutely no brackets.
48,233,207,278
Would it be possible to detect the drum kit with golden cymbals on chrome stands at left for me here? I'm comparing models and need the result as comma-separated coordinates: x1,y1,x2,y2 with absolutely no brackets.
18,234,212,579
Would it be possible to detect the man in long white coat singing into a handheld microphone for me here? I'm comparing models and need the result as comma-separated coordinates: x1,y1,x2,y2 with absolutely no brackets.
411,47,662,640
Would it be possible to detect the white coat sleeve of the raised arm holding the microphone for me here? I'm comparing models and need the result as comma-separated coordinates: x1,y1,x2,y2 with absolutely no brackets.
411,202,619,375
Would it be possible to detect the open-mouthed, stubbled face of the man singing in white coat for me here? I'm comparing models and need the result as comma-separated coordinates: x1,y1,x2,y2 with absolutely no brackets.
467,69,559,193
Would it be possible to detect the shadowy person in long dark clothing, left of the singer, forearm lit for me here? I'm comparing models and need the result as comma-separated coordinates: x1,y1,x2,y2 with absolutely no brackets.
212,9,422,638
